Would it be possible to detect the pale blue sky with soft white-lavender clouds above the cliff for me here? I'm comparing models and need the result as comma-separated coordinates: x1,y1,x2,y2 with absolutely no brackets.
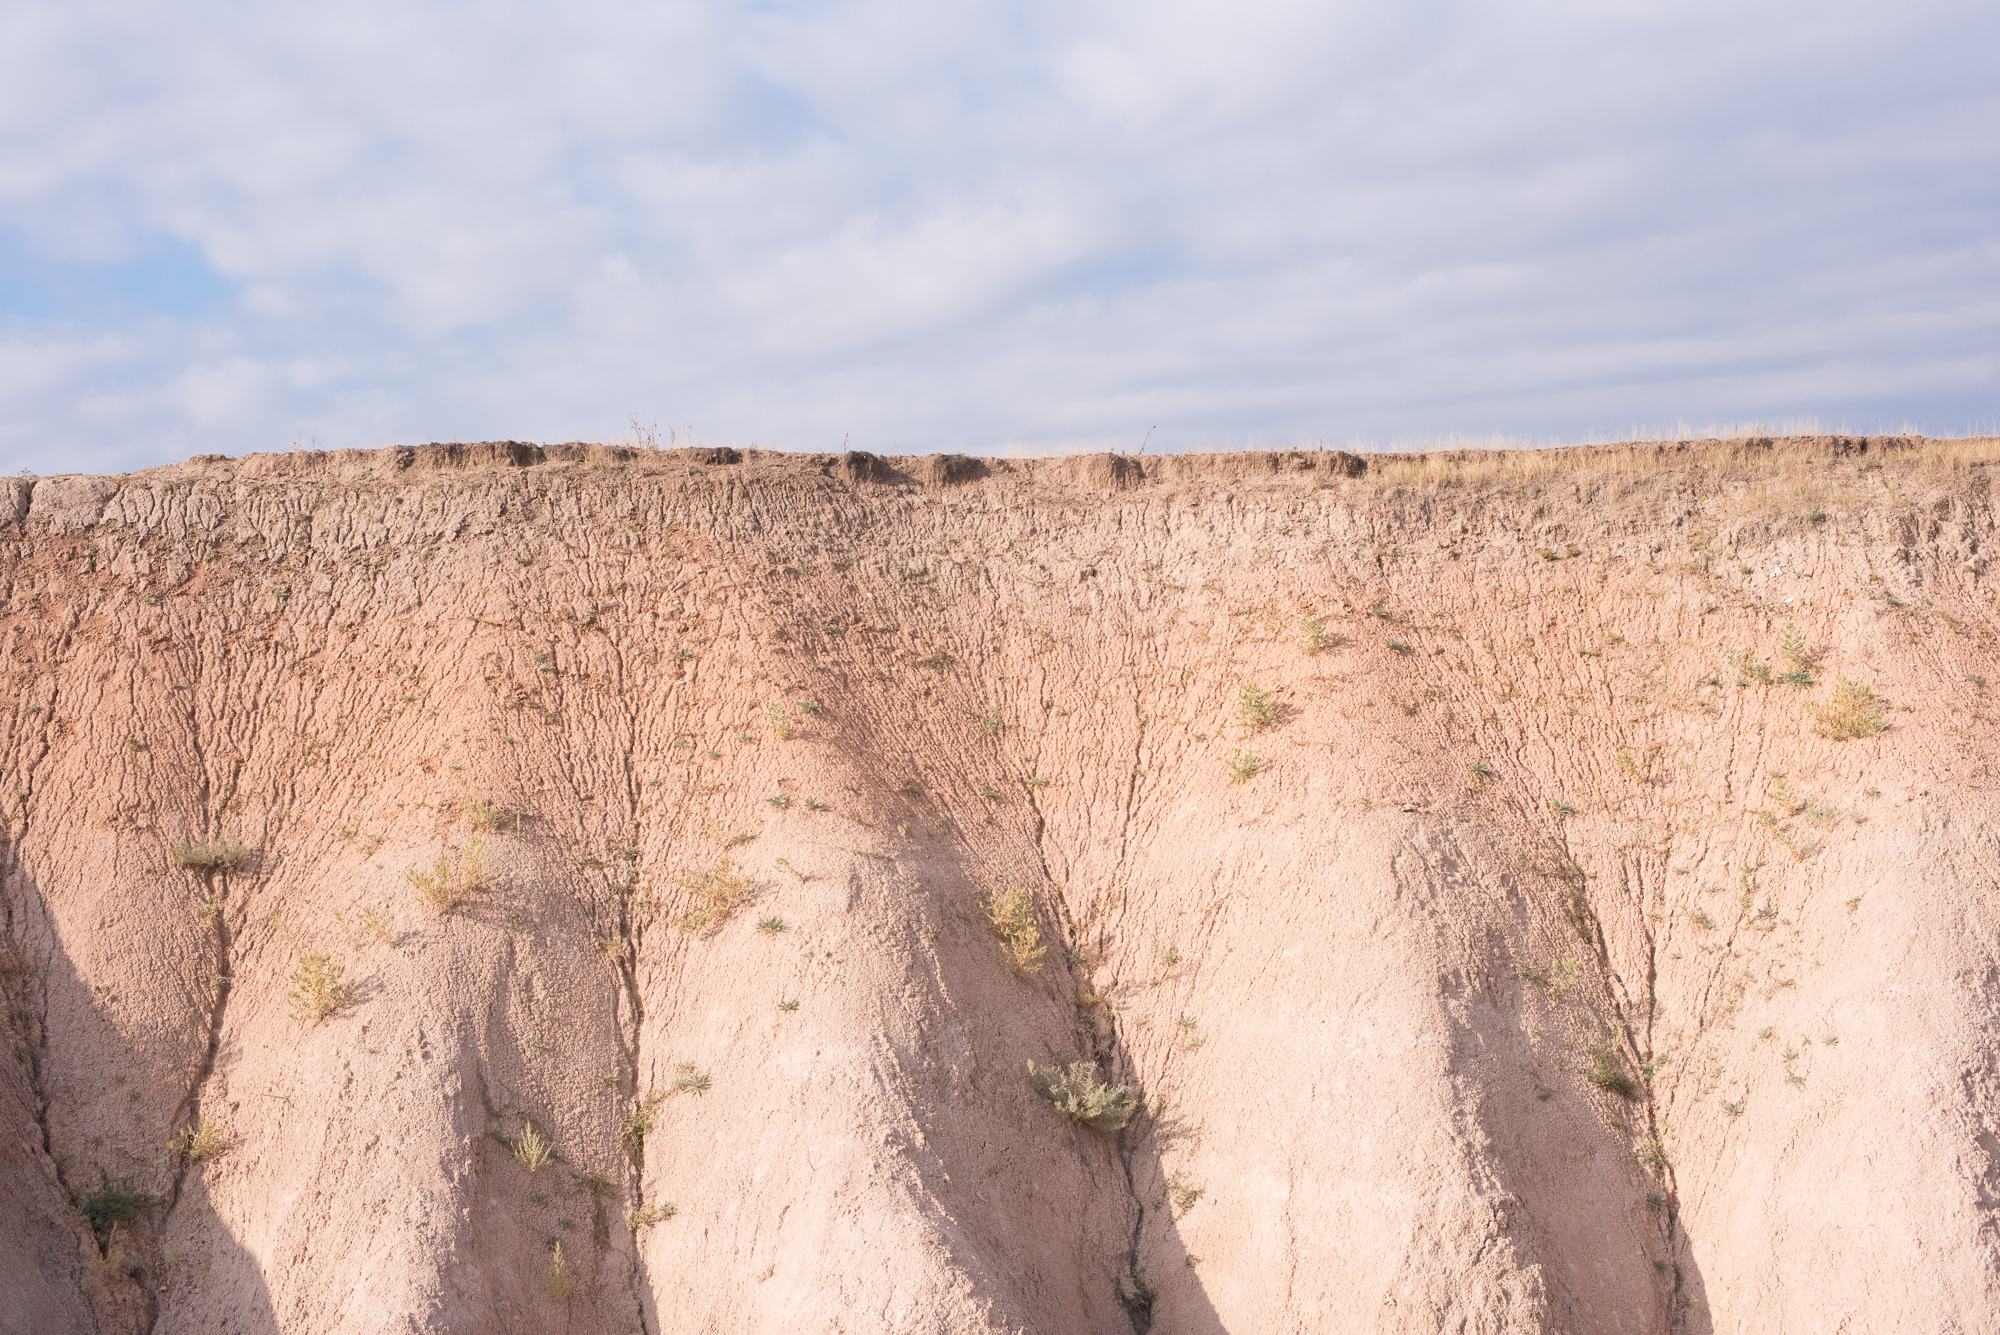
0,0,2000,476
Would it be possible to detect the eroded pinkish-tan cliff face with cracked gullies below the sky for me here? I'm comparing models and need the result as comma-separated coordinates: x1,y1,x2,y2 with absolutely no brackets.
0,440,2000,1335
